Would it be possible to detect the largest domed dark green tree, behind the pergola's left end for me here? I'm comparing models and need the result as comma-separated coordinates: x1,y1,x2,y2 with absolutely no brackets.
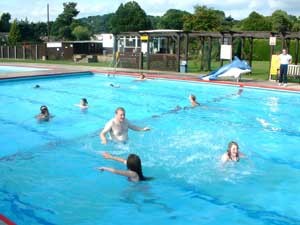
111,1,151,33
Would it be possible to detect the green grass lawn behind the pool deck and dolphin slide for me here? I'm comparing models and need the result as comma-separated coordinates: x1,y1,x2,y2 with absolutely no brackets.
0,59,270,80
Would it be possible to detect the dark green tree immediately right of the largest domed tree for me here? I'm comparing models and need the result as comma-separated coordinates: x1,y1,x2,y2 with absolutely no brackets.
158,9,190,30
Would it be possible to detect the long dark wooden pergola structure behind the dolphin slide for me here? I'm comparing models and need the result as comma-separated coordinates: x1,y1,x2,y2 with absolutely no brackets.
114,30,300,71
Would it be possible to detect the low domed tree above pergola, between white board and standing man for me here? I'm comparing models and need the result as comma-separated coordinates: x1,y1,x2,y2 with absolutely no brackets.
241,12,271,31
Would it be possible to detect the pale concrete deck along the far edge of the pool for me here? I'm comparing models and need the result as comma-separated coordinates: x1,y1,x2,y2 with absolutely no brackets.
0,62,300,92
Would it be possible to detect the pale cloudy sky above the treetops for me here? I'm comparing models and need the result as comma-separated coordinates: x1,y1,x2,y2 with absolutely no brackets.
0,0,300,22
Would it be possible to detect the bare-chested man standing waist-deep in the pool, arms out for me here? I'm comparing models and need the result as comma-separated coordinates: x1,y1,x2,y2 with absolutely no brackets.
99,107,150,144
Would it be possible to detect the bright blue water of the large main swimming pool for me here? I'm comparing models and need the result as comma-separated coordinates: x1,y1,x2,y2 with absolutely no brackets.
0,75,300,225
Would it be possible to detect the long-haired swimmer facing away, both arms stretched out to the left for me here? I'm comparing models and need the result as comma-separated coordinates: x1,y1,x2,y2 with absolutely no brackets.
97,152,151,182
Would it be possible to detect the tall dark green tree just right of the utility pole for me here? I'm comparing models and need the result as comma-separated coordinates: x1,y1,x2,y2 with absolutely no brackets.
51,2,79,40
